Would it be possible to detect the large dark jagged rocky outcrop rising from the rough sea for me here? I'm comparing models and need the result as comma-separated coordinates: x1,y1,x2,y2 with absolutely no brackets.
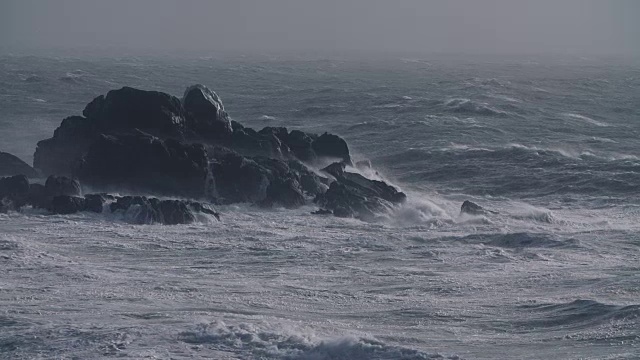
28,85,405,224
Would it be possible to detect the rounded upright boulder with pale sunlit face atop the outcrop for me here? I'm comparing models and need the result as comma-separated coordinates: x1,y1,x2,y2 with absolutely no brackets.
182,84,233,138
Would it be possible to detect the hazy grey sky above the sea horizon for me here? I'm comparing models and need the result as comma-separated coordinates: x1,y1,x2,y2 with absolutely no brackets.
0,0,640,54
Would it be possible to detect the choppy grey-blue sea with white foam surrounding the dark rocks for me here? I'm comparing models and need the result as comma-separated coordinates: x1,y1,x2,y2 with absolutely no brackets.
0,55,640,360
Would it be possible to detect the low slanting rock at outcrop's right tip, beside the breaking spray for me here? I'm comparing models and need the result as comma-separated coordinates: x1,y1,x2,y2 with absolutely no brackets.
315,172,406,220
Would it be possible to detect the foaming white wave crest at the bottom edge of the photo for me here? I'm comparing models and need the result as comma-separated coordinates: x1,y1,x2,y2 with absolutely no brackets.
178,322,460,360
